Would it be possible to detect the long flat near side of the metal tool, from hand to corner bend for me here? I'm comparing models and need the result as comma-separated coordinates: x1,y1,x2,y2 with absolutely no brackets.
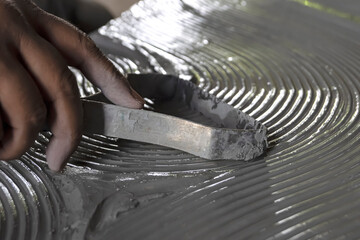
82,100,217,159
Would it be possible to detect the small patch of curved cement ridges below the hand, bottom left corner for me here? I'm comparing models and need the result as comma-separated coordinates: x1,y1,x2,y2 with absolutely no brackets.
0,156,63,240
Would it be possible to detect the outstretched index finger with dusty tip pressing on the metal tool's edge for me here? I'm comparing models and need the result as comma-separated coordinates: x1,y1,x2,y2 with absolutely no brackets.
21,3,144,108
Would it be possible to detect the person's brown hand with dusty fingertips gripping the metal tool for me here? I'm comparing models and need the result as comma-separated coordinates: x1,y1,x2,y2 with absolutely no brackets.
0,0,144,171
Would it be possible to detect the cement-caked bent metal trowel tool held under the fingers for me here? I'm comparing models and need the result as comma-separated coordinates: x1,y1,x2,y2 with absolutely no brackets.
82,74,267,161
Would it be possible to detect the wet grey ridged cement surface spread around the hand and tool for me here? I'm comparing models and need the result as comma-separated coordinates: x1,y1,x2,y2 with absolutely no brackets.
0,0,360,239
